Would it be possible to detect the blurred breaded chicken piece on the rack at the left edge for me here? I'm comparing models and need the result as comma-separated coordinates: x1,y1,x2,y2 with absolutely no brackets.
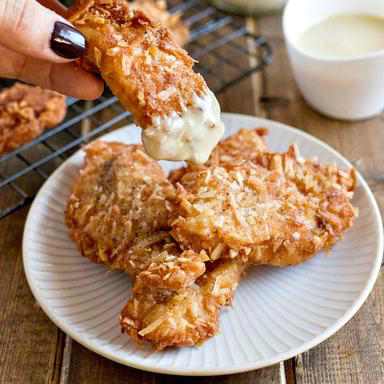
0,83,67,156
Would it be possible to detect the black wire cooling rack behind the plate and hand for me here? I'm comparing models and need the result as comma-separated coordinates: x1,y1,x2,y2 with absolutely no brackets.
0,0,272,219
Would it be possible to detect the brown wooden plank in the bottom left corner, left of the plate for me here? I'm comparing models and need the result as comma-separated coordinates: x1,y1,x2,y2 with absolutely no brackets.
0,208,64,383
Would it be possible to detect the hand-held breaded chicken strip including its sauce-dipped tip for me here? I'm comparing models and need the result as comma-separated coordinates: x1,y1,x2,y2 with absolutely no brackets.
69,0,224,163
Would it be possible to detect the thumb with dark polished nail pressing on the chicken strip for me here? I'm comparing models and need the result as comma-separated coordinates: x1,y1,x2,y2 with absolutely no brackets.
0,0,86,63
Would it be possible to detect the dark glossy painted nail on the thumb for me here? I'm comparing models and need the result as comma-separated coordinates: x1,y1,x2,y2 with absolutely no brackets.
51,21,86,59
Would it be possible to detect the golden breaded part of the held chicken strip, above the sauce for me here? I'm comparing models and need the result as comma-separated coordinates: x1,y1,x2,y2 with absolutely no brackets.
69,0,207,128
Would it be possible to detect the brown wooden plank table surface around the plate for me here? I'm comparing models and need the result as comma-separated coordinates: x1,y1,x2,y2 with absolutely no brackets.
0,12,384,384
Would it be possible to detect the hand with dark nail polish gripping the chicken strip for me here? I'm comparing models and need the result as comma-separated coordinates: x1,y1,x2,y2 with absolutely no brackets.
0,0,103,99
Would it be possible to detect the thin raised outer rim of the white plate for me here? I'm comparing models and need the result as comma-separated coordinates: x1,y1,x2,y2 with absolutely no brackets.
22,113,383,376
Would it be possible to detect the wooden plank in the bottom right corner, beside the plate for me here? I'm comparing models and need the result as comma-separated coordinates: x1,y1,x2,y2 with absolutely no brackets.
295,271,384,384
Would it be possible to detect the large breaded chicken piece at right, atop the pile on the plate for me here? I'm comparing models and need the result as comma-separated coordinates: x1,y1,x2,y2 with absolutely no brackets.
172,142,357,265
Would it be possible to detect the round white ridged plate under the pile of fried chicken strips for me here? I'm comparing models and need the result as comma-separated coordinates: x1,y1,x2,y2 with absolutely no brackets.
23,114,383,375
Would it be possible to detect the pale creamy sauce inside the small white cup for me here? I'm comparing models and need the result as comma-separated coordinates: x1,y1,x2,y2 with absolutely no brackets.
297,13,384,57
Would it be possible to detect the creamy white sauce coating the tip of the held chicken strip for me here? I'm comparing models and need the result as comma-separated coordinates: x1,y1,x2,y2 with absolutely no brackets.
141,89,224,164
